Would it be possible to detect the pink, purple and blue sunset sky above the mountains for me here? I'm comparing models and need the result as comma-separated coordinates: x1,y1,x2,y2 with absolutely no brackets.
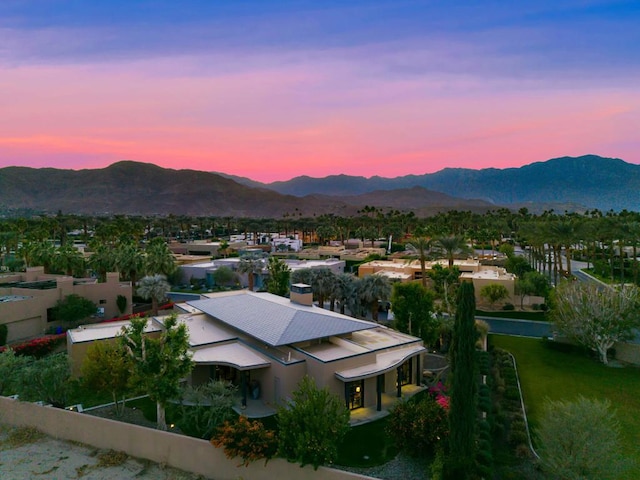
0,0,640,182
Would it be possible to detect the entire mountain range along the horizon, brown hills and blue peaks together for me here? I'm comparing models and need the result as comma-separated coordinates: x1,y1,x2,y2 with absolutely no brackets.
0,155,640,218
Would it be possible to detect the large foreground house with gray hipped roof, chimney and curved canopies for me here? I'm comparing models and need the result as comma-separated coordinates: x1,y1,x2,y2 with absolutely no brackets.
68,284,426,411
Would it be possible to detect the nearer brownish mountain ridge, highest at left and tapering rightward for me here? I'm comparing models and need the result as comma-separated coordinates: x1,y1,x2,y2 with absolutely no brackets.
0,161,494,218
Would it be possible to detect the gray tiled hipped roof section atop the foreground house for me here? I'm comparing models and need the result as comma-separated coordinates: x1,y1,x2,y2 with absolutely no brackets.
187,292,379,347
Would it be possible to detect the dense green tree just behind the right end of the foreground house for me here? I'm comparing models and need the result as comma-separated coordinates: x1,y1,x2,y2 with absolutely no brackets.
391,282,440,345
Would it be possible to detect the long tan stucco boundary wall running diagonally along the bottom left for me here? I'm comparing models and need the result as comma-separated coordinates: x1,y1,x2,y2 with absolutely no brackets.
0,397,371,480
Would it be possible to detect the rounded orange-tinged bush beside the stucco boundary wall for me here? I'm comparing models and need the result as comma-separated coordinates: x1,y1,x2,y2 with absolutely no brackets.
211,416,278,467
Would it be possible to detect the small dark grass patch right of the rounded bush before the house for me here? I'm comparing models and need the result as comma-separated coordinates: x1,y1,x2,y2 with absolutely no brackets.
336,416,398,467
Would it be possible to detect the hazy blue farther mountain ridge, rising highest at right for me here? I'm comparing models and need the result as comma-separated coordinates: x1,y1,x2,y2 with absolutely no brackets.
225,155,640,211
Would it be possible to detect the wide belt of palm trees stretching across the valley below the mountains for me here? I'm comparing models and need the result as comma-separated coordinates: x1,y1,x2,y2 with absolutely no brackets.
0,206,640,283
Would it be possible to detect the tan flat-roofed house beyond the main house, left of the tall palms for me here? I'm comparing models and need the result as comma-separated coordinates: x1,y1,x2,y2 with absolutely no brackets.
358,259,519,304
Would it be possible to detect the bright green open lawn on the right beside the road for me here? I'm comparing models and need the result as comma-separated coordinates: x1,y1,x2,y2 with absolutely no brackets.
489,335,640,478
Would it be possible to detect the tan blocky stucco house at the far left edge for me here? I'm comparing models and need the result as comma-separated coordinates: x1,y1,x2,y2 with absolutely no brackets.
0,267,132,342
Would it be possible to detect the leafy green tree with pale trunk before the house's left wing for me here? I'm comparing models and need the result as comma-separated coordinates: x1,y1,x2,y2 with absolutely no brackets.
120,314,193,430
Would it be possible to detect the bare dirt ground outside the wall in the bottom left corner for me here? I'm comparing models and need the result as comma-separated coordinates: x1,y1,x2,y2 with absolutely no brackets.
0,425,211,480
